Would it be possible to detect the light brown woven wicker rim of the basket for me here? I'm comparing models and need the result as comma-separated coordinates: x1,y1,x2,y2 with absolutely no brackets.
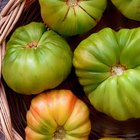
0,0,34,140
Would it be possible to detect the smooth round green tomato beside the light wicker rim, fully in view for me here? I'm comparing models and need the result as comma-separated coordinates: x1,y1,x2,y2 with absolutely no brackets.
2,22,72,94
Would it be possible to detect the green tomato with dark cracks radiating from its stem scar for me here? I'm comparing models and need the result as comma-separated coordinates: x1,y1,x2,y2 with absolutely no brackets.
39,0,107,36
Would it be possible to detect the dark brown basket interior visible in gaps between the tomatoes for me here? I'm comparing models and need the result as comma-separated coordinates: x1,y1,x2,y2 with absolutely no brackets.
3,0,140,140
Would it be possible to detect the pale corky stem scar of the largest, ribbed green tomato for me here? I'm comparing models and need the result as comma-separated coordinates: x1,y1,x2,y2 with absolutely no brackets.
111,64,127,76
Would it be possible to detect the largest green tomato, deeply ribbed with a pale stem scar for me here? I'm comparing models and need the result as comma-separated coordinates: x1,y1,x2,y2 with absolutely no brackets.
73,28,140,121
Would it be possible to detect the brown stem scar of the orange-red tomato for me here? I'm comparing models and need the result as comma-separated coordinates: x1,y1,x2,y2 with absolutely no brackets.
53,126,65,140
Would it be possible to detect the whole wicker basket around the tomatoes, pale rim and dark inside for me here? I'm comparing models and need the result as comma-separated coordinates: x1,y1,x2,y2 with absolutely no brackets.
0,0,140,140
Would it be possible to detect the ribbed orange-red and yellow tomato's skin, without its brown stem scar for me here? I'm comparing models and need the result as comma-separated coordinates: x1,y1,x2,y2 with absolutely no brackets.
25,89,91,140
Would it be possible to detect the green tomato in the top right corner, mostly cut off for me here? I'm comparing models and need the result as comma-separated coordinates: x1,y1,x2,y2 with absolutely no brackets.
111,0,140,21
